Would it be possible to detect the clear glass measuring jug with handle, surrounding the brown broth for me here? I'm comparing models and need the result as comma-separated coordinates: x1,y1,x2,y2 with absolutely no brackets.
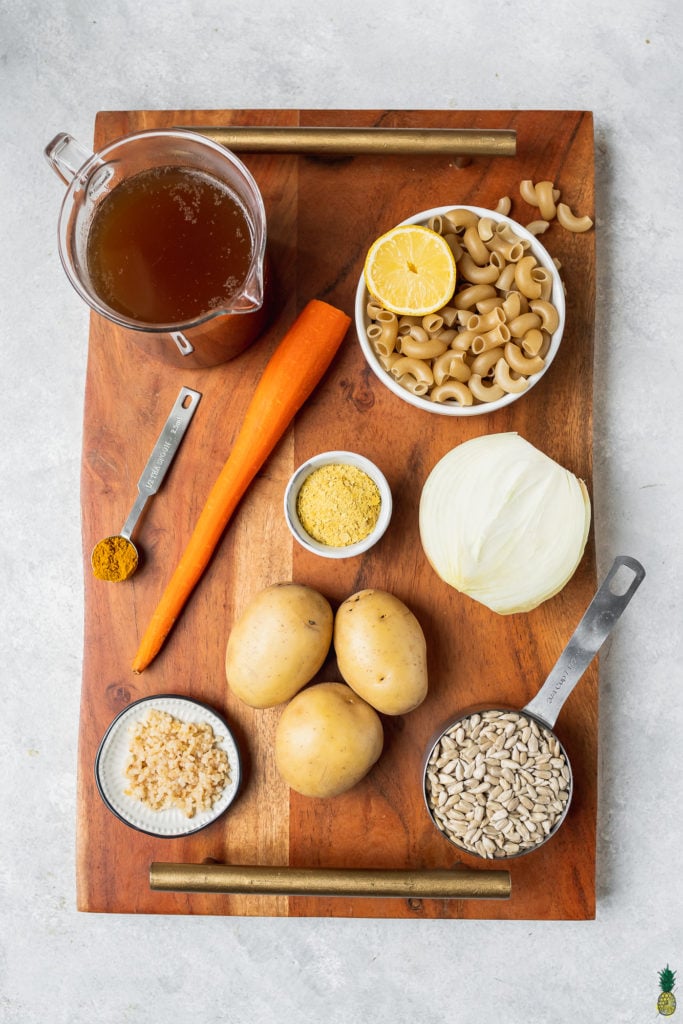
45,129,269,369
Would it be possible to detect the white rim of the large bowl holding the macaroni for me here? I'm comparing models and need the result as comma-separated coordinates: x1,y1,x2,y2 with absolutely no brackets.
355,204,566,416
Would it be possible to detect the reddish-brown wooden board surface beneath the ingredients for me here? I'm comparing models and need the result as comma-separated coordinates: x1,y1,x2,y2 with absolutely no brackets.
77,110,598,920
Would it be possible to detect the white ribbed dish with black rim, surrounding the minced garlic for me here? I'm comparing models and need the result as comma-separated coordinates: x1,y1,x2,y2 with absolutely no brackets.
94,693,242,839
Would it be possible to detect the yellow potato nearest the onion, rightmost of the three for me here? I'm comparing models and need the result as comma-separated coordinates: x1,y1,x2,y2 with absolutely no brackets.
334,590,427,715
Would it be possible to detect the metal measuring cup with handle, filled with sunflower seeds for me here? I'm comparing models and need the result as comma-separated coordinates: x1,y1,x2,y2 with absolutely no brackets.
423,555,645,859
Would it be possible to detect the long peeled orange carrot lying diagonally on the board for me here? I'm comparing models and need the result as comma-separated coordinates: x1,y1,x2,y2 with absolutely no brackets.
133,299,351,673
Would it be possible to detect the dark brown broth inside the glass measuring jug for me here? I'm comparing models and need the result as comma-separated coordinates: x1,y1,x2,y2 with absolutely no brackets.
87,167,253,325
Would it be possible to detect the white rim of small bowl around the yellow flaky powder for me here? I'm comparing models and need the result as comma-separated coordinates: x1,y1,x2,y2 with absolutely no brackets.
285,452,392,558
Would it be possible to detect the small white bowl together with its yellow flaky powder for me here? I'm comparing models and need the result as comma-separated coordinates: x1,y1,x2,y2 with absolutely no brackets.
285,451,392,558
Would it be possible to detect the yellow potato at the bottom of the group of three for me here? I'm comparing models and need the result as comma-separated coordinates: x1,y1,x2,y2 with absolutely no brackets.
275,683,384,797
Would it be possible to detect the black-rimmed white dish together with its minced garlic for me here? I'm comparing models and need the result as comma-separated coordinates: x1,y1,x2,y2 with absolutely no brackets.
95,694,241,838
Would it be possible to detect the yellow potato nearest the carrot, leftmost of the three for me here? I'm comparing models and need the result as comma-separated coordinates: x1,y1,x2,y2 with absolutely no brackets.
225,582,334,708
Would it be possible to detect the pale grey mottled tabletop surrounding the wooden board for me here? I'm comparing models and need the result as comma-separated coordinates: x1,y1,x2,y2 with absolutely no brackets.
0,0,683,1024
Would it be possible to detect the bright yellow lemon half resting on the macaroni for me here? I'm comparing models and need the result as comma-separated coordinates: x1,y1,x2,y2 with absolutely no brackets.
362,224,456,316
